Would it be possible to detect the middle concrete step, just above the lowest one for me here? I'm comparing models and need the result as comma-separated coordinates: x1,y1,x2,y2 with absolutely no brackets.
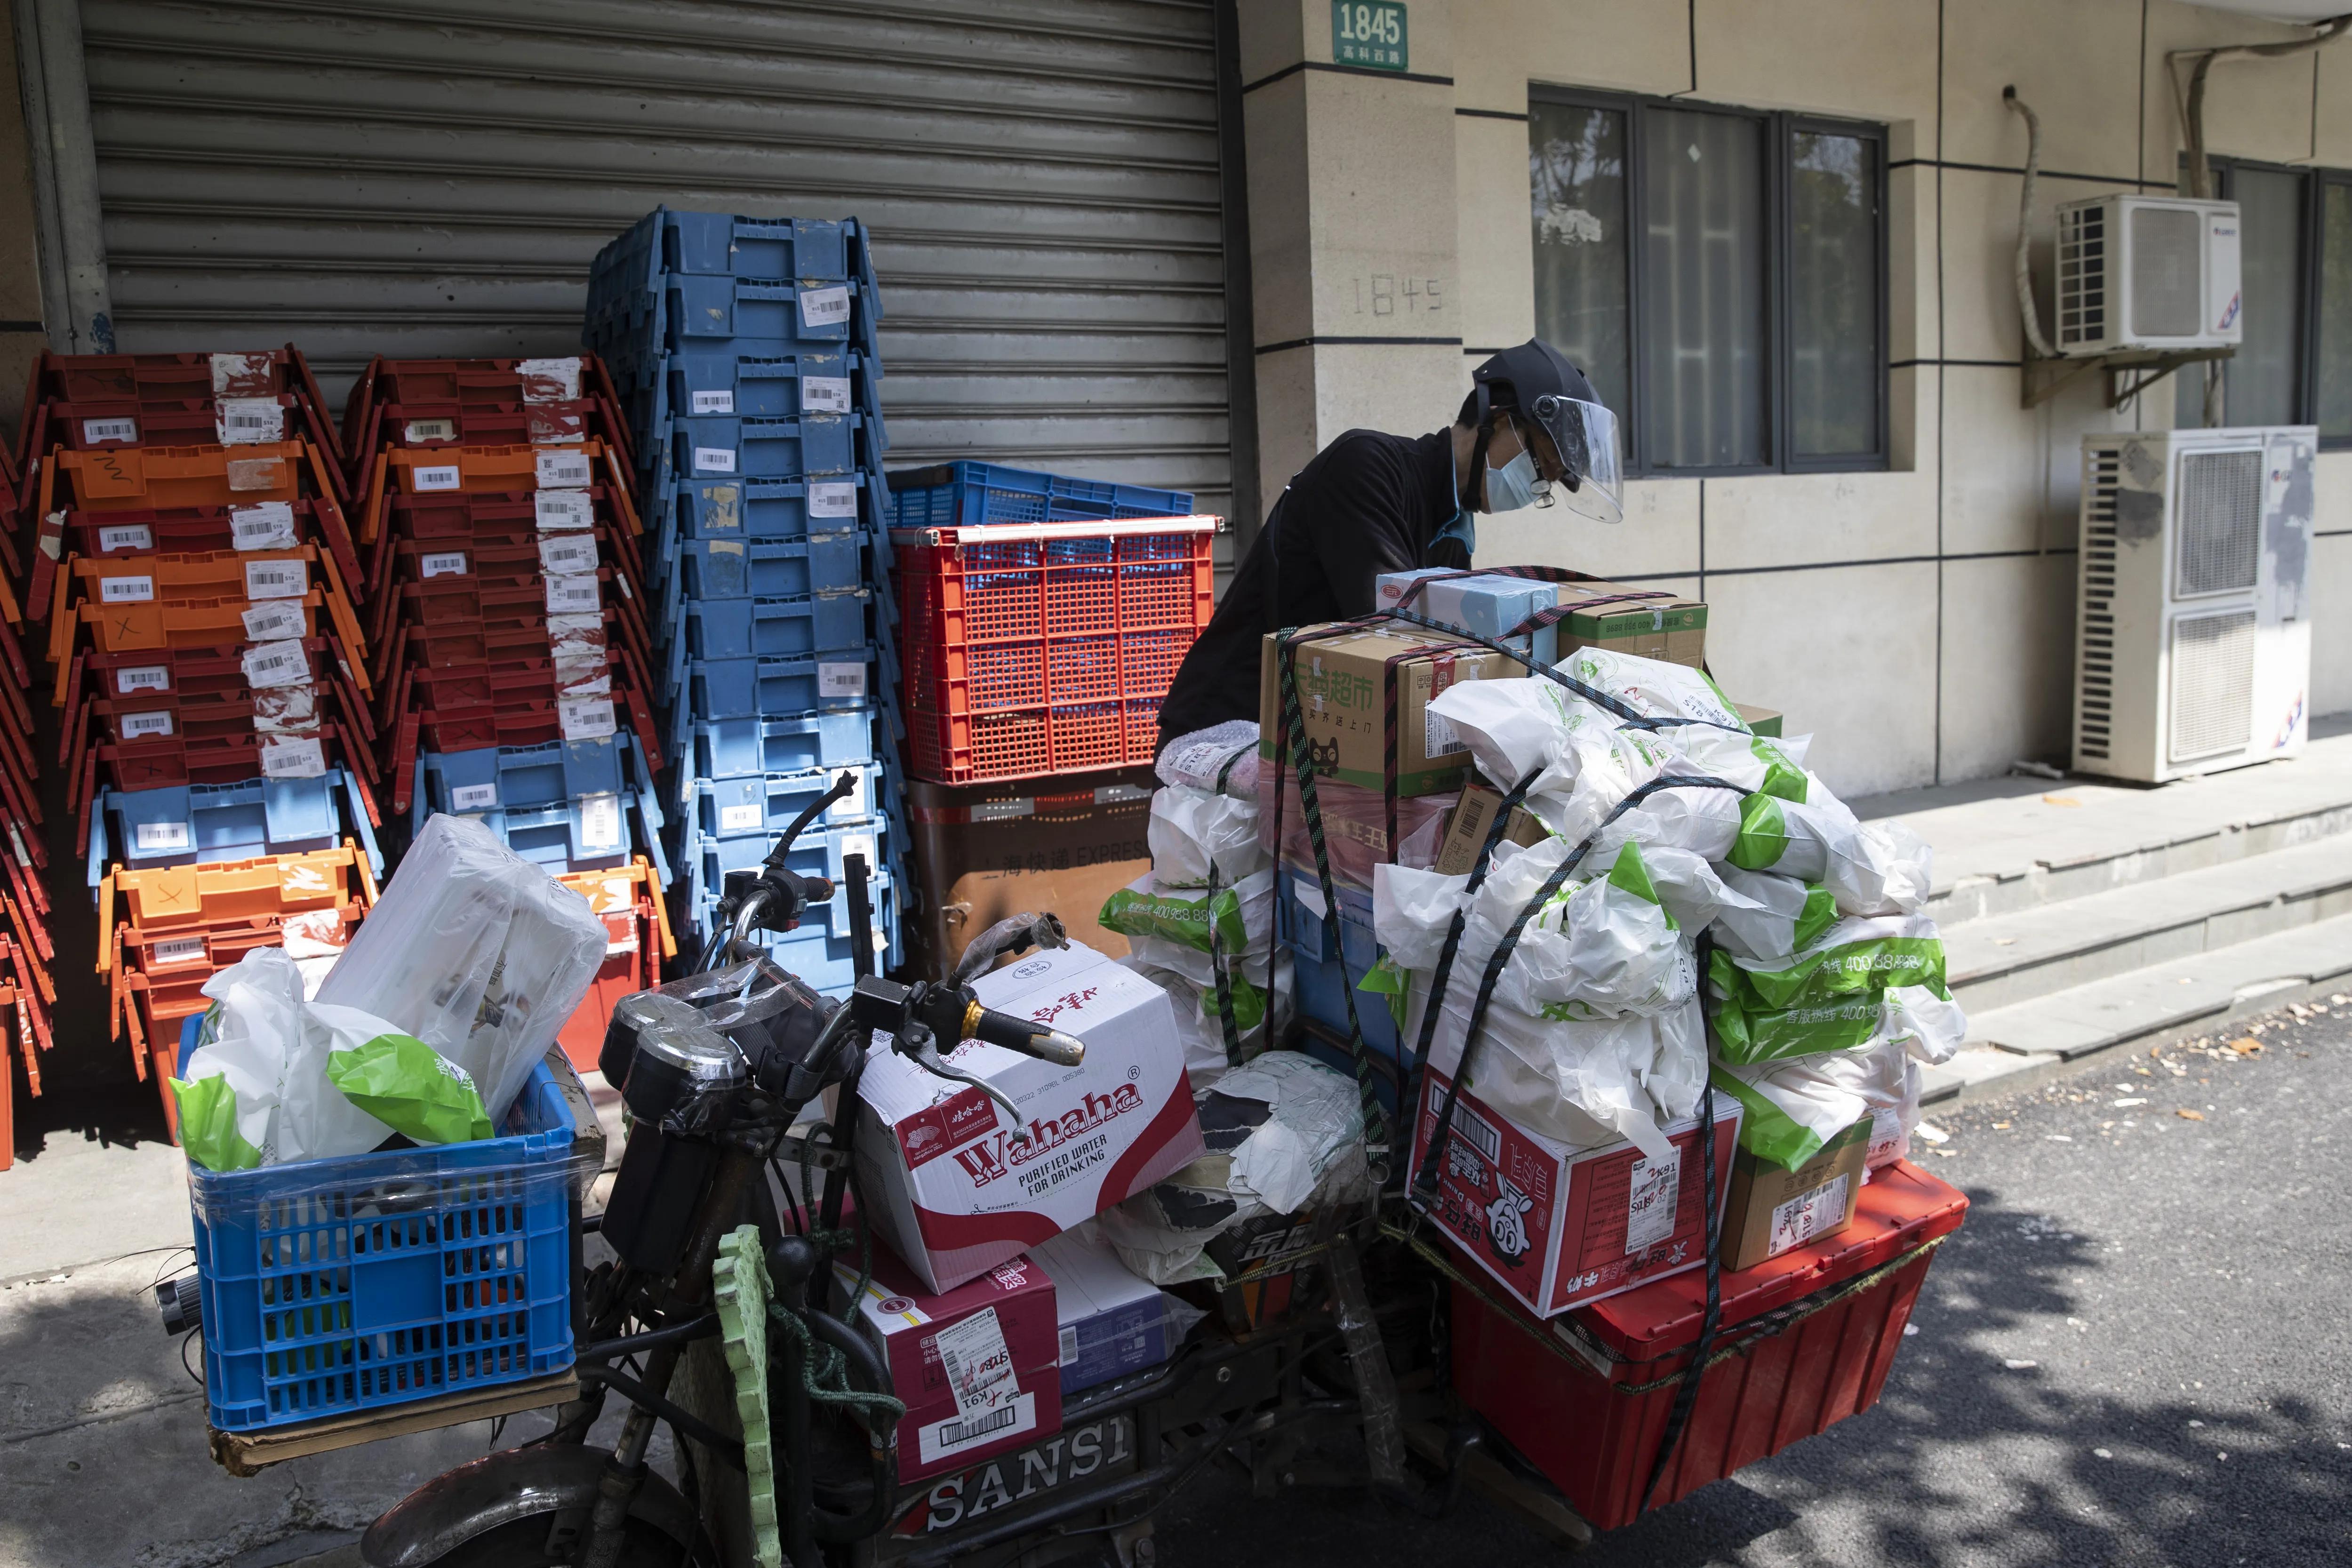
1943,834,2352,1018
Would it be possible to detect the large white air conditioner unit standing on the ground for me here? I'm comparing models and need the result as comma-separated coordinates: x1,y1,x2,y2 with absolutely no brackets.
2074,425,2319,783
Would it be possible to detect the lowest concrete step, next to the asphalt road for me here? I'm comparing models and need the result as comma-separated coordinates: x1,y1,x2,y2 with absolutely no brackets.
1928,914,2352,1100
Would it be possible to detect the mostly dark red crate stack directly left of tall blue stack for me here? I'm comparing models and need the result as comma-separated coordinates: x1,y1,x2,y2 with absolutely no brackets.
344,355,677,1067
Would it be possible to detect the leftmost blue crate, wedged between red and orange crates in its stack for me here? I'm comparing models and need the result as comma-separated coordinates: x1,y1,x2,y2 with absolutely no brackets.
89,769,384,886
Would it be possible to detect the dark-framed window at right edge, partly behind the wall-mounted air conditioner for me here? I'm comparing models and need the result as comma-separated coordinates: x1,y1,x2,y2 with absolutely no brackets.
2173,158,2352,451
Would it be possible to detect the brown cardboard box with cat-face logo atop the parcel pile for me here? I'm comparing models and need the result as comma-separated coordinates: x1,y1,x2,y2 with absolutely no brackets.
1258,625,1527,794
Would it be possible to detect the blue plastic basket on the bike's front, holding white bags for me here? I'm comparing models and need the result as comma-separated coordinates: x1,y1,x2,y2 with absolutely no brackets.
188,1063,574,1432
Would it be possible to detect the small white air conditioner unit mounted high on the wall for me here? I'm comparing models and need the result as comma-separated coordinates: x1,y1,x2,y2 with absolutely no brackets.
2058,195,2246,357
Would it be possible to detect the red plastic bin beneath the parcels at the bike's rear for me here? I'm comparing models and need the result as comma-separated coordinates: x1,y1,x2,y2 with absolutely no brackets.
1454,1161,1968,1530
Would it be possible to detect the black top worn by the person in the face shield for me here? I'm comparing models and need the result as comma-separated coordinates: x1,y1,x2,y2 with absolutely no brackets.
1160,430,1470,745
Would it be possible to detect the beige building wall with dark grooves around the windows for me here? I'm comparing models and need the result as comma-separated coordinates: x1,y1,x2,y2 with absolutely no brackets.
1242,0,2352,792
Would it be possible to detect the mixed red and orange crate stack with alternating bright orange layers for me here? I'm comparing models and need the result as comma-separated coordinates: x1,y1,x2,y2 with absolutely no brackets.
19,348,376,1133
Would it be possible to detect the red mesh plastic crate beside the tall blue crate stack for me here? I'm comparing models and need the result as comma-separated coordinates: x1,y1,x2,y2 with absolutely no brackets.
891,517,1218,783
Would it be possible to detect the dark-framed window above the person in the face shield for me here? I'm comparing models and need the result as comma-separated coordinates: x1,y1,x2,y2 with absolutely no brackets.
1527,87,1891,475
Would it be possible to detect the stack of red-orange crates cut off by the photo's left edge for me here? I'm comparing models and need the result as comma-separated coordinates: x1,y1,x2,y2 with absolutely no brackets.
0,430,56,1152
